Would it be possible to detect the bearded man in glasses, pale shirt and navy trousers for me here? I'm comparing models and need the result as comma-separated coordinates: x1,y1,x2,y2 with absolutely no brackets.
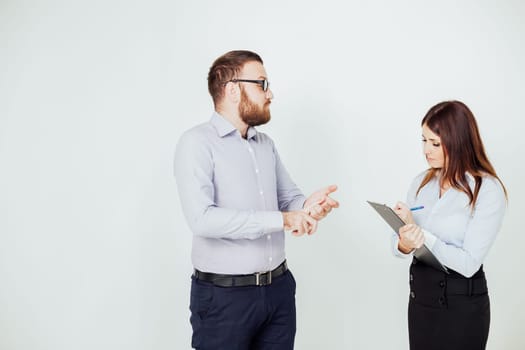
175,51,339,350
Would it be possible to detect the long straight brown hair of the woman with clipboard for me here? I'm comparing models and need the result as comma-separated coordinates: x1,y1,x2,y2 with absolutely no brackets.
417,101,507,208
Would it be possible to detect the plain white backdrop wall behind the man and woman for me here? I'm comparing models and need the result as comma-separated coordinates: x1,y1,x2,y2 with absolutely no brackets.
0,0,525,350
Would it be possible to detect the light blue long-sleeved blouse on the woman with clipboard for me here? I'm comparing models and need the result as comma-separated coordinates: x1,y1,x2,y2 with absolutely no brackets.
393,171,506,277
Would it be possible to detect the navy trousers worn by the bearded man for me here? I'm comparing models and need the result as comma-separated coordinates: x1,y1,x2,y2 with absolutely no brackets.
190,270,296,350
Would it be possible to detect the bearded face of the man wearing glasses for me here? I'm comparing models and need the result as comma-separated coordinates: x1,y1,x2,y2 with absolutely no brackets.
239,62,273,126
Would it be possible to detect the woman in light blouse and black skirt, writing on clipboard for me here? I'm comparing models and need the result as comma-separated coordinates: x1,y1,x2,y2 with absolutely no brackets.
394,101,507,350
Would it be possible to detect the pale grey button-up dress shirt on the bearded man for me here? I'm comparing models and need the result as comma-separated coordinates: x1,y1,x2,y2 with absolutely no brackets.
175,113,305,274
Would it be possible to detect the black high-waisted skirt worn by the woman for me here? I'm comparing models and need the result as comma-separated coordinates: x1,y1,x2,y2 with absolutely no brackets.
408,258,490,350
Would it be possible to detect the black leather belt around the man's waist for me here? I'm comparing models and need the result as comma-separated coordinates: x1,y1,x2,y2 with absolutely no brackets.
193,260,288,287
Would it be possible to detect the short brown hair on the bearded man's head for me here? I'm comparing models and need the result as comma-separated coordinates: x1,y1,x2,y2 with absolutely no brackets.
208,50,263,106
